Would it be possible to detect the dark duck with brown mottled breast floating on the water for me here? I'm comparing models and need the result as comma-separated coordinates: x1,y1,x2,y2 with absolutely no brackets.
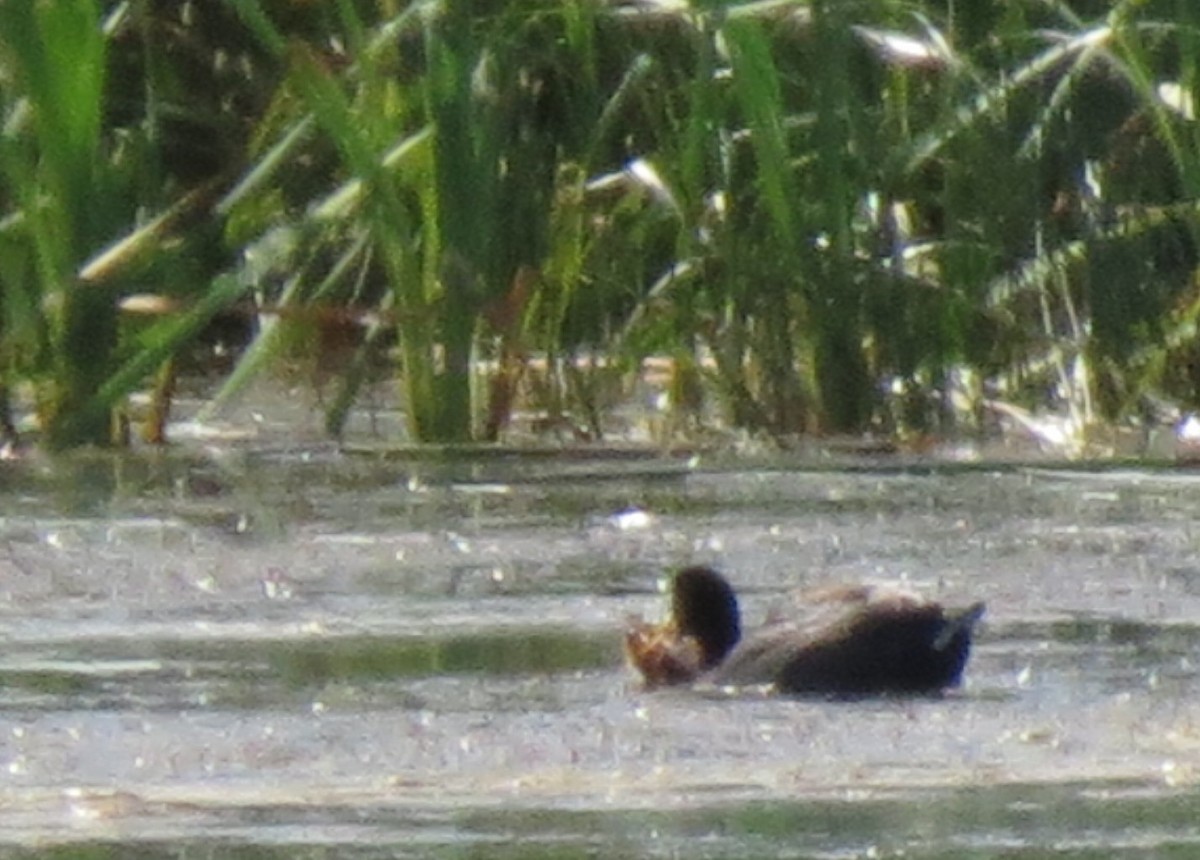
625,566,985,697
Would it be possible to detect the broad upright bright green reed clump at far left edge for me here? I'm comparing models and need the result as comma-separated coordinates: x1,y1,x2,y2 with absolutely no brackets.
0,0,119,446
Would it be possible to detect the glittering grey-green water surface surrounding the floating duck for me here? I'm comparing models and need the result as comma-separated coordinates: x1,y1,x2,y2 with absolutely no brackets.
0,447,1200,859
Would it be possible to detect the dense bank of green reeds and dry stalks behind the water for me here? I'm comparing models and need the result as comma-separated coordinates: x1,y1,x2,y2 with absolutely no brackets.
0,0,1200,447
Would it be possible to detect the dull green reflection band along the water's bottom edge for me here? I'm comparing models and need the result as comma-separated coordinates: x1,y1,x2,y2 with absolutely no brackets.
9,783,1200,860
